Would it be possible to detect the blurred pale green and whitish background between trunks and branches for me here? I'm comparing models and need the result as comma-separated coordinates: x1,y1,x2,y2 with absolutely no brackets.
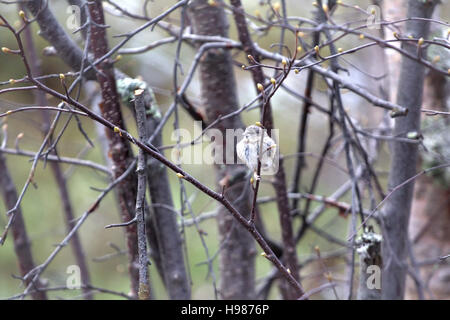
0,0,450,299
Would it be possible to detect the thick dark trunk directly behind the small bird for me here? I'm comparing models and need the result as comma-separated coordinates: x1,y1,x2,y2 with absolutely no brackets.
188,0,256,300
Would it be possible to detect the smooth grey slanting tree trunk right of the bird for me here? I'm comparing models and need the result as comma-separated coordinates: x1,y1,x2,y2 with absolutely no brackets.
381,0,437,299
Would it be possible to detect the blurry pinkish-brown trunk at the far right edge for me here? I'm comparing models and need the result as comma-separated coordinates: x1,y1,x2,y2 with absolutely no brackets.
406,72,450,300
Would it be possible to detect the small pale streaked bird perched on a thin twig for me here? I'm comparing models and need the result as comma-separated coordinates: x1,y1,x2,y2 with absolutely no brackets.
236,125,277,180
